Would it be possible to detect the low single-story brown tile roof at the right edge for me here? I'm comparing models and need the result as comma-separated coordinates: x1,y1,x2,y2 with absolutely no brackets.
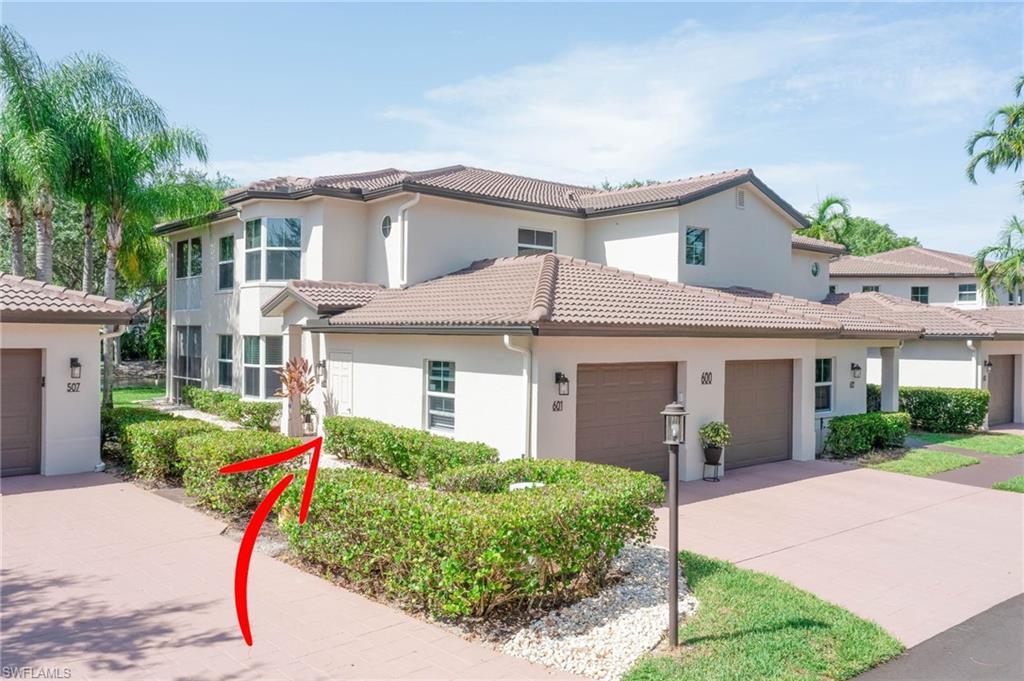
824,292,1024,338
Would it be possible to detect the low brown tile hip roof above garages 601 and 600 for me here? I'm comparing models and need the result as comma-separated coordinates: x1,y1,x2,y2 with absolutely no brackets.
319,254,918,338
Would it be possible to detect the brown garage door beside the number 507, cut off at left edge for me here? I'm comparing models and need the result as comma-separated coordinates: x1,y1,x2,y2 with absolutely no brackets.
0,350,43,475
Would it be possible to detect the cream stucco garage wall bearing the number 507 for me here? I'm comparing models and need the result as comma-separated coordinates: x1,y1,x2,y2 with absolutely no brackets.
0,324,100,475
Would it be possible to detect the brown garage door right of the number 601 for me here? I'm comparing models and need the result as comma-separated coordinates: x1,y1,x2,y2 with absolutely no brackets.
577,363,676,478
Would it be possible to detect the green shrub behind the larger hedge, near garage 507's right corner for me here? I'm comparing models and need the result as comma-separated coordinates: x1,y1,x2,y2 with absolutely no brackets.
121,418,220,480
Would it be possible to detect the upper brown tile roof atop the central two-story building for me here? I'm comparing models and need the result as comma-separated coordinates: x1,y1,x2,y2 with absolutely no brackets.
156,166,807,233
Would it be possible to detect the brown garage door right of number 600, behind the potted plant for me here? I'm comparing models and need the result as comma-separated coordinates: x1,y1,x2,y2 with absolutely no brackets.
725,359,793,469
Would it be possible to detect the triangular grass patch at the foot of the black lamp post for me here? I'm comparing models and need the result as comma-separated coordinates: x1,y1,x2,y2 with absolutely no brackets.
624,551,903,681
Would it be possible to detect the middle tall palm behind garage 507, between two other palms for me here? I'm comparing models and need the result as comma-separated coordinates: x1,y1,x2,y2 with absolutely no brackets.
50,54,167,293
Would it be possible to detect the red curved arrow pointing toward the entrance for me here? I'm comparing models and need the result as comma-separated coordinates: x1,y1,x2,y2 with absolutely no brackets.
220,437,324,646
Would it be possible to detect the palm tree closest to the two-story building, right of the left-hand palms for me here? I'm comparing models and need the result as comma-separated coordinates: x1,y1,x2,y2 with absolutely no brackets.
92,127,220,406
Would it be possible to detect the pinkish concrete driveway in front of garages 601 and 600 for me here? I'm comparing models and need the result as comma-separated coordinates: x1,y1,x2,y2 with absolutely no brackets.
656,461,1024,646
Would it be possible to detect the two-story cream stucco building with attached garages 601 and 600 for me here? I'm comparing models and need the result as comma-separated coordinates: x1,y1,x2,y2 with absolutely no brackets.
157,166,983,479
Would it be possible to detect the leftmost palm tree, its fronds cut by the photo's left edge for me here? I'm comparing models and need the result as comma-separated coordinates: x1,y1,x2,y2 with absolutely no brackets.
0,26,70,282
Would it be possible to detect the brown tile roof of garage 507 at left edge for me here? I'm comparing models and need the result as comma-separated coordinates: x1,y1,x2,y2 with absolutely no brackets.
0,272,135,324
